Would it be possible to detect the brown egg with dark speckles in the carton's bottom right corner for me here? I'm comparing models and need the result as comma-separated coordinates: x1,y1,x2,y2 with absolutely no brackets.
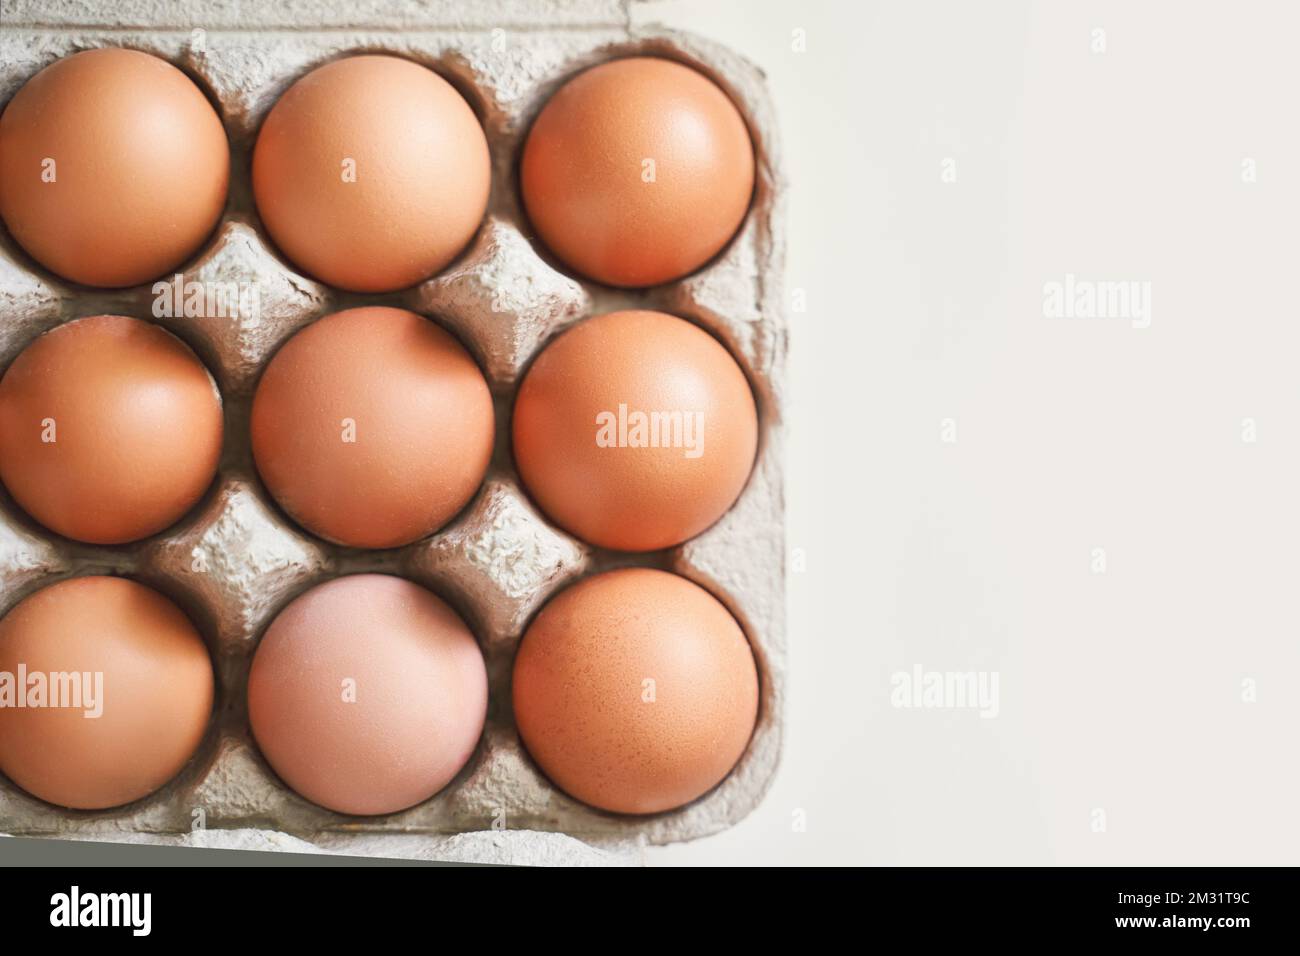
514,568,758,813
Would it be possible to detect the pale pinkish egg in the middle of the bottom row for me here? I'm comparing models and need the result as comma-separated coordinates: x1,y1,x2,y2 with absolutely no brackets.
248,575,488,814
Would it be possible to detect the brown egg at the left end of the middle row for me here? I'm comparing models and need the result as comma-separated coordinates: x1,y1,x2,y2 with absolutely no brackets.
0,315,221,544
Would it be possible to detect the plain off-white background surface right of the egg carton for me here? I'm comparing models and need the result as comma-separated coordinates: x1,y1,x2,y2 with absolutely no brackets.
637,0,1300,865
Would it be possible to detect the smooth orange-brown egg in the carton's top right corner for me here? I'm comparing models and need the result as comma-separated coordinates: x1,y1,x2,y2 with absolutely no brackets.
520,56,754,286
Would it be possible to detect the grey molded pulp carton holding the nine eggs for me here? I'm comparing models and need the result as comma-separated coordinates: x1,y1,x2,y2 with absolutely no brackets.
0,0,787,852
